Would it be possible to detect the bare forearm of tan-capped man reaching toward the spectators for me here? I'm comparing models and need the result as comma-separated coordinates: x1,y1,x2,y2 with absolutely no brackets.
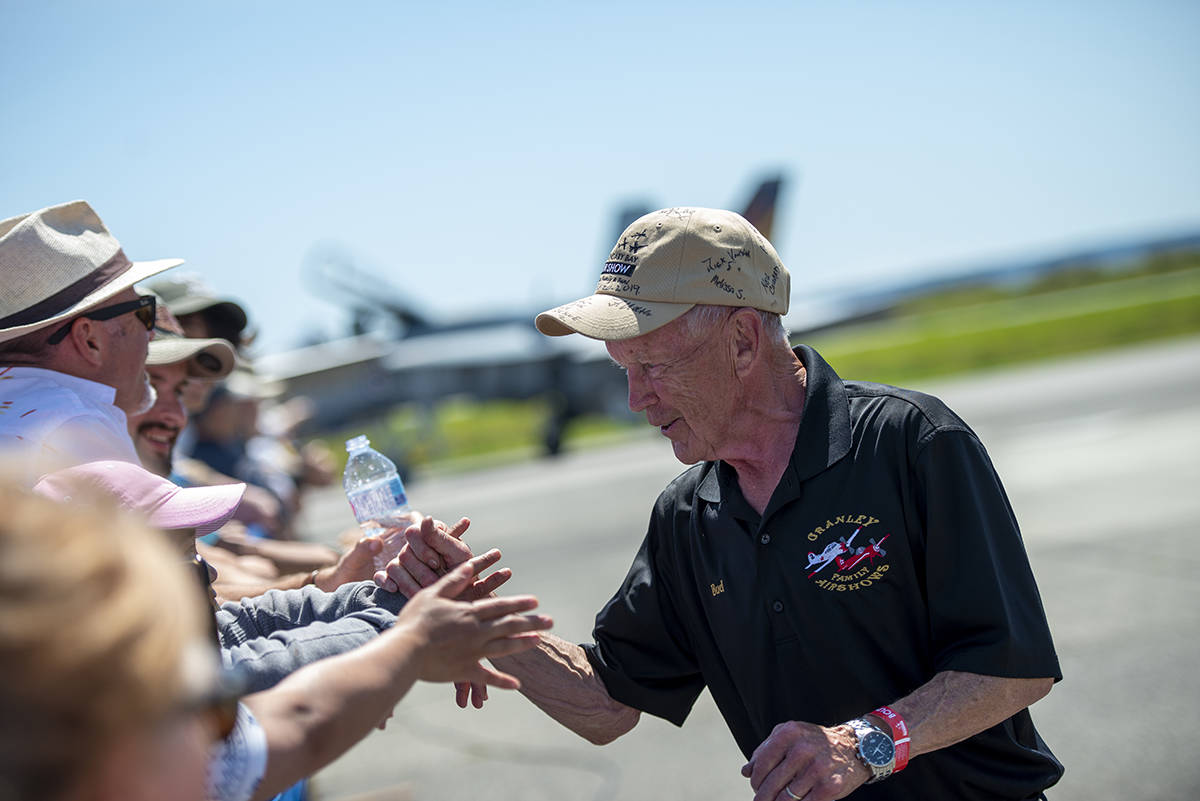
493,632,641,746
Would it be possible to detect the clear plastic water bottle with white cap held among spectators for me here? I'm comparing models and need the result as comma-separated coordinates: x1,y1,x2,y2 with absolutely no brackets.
342,435,412,570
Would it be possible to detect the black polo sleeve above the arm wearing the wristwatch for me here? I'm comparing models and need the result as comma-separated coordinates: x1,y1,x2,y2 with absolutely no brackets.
917,429,1062,680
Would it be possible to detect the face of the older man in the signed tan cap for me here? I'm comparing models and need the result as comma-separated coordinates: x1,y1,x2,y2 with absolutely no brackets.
607,318,736,464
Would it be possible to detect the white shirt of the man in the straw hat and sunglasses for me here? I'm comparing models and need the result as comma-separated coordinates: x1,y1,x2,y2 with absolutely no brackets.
0,367,142,487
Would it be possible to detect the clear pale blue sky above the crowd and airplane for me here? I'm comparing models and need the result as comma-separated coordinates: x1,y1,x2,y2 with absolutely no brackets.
0,0,1200,353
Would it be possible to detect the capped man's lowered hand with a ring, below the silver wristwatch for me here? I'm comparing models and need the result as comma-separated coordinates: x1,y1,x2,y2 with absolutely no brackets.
742,721,871,801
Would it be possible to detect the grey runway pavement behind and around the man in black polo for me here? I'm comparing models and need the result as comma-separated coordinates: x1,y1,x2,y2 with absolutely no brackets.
292,339,1200,801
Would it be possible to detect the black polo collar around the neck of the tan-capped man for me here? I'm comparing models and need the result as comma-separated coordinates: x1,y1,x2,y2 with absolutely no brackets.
696,345,851,512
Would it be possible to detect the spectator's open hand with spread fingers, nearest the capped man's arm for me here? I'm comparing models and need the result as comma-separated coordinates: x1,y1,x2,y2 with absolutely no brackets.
391,549,553,689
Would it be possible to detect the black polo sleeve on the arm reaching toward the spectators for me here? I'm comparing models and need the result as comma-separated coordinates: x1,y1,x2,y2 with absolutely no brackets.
583,513,704,725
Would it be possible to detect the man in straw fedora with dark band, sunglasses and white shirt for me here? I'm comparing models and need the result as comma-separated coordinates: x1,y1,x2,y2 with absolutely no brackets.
0,200,182,484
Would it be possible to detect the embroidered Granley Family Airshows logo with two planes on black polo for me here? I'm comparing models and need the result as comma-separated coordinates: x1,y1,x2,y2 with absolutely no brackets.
805,514,892,592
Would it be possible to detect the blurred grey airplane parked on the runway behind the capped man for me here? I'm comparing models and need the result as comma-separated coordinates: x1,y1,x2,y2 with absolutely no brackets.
254,175,785,453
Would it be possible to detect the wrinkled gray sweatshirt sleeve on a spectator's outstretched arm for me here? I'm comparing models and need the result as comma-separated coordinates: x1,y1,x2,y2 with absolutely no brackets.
216,582,404,692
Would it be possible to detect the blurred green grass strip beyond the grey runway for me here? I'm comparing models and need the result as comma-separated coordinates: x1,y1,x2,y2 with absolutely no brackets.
324,253,1200,472
